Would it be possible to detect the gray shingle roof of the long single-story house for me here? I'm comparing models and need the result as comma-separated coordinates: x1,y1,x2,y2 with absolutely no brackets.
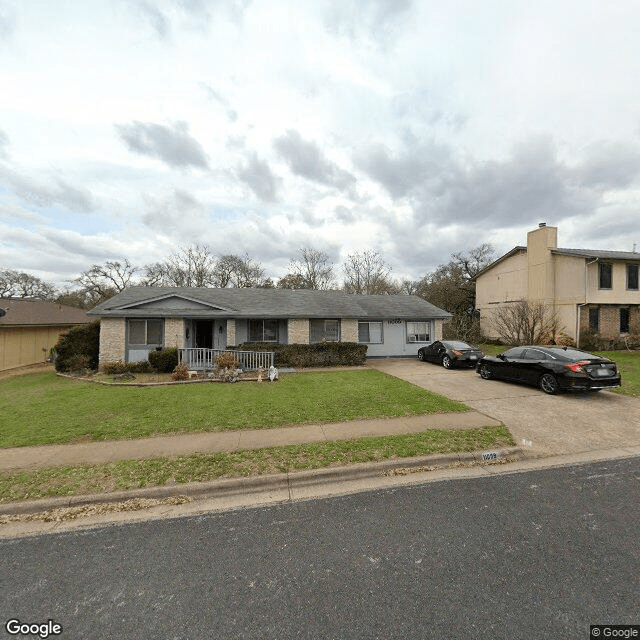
89,287,450,320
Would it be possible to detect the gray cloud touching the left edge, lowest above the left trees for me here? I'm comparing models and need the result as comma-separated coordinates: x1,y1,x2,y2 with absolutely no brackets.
0,170,97,213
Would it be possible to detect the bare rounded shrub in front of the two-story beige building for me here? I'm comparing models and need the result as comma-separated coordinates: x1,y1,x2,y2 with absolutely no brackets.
492,300,564,345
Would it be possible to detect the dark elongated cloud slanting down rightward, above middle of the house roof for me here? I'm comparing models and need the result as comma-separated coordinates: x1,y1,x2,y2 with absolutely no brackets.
273,129,356,189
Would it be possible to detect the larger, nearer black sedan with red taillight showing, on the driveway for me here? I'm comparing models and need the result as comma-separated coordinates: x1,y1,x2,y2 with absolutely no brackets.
476,345,621,394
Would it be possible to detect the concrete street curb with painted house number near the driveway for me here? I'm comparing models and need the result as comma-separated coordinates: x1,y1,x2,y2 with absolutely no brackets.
0,447,524,515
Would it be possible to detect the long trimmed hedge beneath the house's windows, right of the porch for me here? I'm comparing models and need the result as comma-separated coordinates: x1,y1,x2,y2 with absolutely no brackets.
237,342,367,369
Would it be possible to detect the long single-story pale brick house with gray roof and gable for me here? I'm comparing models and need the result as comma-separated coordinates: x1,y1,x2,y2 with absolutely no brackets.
89,287,451,365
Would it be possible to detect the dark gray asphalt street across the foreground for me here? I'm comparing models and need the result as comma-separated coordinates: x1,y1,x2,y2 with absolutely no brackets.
0,457,640,640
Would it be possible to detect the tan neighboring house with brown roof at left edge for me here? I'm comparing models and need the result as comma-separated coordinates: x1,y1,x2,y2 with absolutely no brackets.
0,298,91,371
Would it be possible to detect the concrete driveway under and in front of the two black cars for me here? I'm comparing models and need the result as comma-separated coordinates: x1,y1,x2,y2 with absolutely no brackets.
368,359,640,456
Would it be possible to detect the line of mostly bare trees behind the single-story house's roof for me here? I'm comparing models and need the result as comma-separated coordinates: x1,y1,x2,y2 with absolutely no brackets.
0,244,495,337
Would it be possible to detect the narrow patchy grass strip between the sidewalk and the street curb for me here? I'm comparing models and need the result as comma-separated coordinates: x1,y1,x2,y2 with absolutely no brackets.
0,427,515,502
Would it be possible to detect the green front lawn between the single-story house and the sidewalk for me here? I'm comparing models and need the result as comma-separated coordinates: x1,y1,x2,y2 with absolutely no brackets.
0,369,469,448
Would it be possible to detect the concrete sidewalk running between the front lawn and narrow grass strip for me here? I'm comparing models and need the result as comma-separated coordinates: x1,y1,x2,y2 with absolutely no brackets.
0,411,502,472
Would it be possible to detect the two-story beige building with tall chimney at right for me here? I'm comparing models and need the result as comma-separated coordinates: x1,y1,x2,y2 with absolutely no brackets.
476,223,640,345
